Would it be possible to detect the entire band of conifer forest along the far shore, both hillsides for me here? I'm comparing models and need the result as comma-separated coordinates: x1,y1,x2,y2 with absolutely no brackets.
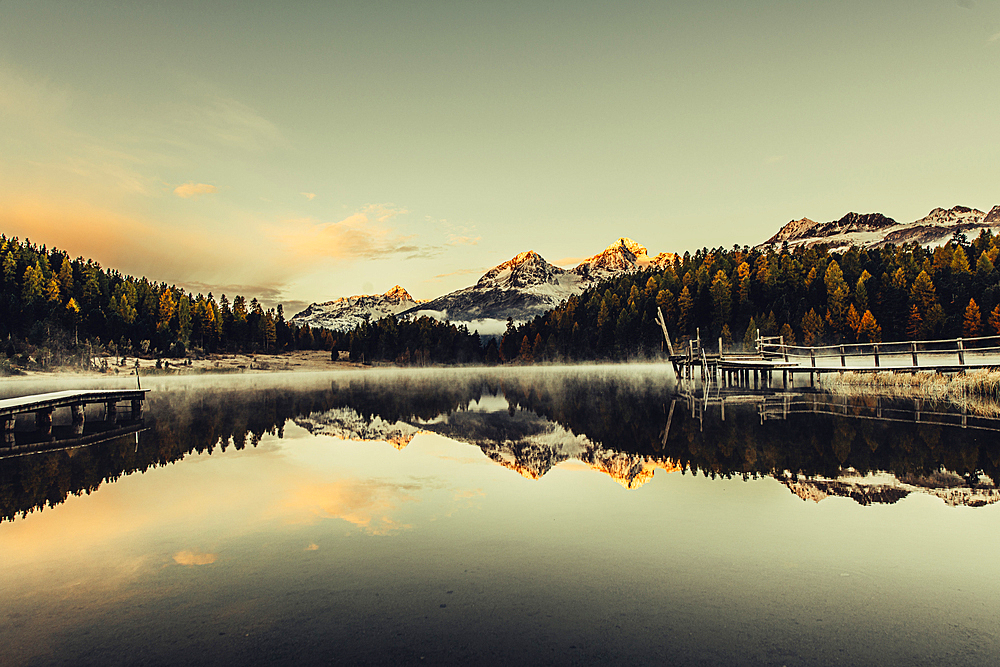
0,233,1000,368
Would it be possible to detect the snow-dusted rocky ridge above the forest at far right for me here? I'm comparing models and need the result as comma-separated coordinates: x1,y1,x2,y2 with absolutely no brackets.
761,206,1000,252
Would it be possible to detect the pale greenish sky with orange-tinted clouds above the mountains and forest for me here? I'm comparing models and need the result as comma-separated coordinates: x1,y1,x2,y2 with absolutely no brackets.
0,0,1000,310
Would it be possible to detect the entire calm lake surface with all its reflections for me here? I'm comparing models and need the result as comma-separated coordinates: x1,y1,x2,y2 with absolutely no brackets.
0,367,1000,665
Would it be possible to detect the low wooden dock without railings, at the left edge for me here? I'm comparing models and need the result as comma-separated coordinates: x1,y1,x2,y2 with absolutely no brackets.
0,389,149,448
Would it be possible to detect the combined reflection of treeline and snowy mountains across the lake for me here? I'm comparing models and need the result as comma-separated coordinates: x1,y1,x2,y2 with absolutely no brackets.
0,368,1000,520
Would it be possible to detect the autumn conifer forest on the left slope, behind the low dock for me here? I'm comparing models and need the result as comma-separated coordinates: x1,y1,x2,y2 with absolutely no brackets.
0,235,334,368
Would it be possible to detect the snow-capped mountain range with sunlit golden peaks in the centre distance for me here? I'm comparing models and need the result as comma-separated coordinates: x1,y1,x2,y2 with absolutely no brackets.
292,237,676,334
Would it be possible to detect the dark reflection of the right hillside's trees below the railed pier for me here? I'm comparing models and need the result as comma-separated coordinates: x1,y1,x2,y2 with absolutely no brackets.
504,378,1000,483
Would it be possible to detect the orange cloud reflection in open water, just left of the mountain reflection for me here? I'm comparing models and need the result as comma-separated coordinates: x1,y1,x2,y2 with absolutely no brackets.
285,479,421,535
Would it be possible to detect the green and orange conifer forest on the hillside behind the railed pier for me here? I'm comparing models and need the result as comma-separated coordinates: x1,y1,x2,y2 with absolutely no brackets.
342,232,1000,363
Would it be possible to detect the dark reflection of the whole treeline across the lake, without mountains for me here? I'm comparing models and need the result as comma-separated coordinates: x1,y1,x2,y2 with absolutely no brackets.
0,372,1000,520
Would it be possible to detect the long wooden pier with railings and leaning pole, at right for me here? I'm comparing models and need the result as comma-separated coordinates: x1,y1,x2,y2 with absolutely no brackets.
657,313,1000,389
